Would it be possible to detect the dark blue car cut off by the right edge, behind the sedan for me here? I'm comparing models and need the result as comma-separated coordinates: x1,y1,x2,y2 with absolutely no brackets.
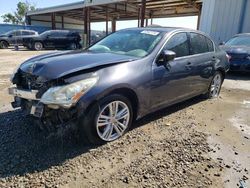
221,33,250,72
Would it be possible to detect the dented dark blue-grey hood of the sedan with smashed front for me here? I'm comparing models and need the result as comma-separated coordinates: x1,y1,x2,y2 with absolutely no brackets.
20,50,138,79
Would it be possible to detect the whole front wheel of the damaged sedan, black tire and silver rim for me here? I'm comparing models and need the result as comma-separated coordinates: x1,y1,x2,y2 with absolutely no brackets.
79,94,133,145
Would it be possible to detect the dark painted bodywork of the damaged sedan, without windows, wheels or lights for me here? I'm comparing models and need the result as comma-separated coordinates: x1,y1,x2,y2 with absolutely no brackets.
9,28,229,122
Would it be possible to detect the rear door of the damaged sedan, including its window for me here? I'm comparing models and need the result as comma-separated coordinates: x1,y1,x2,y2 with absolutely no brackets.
189,32,216,94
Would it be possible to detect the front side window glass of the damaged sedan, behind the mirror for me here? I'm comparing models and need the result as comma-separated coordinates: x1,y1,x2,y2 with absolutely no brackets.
164,33,189,57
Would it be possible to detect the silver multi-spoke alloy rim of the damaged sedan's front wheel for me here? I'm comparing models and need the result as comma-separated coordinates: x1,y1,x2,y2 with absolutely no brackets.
96,101,130,141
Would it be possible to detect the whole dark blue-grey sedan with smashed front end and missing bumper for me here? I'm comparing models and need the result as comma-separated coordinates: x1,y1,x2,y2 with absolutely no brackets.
9,28,229,144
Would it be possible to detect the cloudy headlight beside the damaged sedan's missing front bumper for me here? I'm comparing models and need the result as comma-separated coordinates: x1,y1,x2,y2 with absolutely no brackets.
41,77,98,108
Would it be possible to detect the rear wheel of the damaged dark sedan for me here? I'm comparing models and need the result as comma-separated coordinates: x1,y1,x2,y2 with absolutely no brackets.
205,71,223,99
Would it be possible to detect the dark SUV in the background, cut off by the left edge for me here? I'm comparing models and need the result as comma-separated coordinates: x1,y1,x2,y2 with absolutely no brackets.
0,30,38,49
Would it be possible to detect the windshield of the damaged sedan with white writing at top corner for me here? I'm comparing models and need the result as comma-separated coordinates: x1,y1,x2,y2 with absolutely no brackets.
89,30,163,57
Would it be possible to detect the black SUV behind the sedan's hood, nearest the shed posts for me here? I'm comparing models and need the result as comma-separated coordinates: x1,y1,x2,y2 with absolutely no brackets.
23,30,81,50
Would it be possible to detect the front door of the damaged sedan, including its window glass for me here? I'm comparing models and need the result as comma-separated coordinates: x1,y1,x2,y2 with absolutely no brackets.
151,32,193,108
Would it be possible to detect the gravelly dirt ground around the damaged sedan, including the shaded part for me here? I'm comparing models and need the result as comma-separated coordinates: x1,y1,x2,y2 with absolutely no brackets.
0,50,250,188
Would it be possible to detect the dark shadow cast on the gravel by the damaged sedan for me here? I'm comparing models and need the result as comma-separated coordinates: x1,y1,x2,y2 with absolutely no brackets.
0,97,203,178
